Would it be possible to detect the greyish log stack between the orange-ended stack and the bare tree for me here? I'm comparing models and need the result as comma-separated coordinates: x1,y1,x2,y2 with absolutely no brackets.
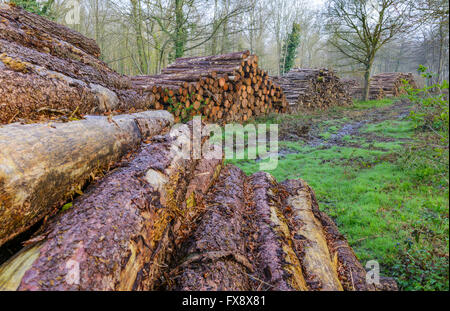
272,68,352,111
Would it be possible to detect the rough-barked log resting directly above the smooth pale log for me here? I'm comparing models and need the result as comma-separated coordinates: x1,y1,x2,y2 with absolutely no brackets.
0,61,146,124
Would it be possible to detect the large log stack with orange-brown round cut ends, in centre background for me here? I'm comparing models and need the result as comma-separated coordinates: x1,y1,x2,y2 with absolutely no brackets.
131,51,287,122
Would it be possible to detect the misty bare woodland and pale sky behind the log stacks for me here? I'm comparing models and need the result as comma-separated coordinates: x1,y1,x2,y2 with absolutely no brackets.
9,0,449,86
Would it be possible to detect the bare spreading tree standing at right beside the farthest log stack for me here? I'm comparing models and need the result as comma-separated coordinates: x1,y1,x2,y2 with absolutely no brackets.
326,0,411,100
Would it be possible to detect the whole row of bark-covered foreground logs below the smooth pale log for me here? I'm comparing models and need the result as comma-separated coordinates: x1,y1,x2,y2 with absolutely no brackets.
0,157,392,291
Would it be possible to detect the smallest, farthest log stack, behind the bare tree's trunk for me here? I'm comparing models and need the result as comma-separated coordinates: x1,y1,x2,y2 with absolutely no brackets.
343,72,417,100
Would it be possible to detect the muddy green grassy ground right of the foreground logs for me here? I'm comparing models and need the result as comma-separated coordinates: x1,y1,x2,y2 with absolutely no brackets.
228,99,449,290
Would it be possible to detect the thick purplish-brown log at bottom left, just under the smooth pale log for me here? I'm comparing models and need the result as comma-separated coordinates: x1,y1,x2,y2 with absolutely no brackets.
0,123,220,290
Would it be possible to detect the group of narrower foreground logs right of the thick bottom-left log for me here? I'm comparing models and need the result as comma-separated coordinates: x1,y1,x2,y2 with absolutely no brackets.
166,166,386,291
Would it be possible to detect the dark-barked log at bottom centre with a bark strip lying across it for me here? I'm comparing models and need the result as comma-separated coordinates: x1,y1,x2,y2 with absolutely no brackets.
173,166,253,290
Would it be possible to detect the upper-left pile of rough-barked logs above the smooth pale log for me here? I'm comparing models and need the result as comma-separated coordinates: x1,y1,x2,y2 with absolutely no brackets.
0,3,146,124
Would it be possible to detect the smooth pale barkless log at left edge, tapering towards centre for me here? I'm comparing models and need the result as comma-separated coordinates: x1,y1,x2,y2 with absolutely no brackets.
0,111,173,245
